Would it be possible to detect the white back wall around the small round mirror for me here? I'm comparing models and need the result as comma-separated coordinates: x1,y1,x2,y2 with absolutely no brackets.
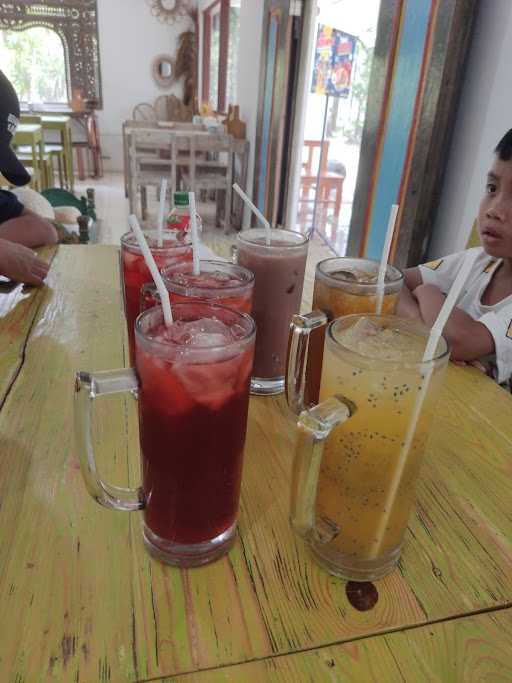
94,0,191,171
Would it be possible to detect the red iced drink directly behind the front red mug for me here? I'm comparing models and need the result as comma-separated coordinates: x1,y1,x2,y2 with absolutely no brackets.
162,261,254,314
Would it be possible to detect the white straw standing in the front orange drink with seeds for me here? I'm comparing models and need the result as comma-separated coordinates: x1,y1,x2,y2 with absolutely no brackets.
370,250,478,559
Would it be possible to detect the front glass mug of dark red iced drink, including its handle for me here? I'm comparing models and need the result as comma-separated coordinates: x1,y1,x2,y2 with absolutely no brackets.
75,302,256,567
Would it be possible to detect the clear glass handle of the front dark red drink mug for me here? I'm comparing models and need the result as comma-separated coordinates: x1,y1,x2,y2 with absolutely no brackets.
75,368,145,511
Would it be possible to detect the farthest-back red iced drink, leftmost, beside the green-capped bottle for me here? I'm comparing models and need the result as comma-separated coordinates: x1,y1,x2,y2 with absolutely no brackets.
121,230,192,365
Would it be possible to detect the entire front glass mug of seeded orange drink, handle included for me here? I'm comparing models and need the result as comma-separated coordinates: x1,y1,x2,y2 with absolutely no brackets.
289,312,449,581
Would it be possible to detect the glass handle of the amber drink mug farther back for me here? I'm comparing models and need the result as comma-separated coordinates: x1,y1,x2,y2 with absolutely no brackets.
286,311,328,415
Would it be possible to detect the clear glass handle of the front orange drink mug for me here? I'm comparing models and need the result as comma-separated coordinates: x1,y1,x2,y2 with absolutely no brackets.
290,395,356,543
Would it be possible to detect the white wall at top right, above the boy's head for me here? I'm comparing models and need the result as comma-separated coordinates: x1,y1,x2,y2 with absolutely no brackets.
429,0,512,258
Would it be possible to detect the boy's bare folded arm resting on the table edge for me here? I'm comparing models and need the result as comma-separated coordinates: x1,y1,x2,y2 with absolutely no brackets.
414,285,495,361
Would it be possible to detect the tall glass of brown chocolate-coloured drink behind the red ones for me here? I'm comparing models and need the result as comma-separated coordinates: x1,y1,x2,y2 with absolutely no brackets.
237,229,308,394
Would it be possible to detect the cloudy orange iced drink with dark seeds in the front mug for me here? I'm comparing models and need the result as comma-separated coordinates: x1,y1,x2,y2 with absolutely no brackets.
314,316,448,580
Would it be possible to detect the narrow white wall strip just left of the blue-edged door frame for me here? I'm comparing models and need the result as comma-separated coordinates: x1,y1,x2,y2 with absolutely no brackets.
237,0,264,226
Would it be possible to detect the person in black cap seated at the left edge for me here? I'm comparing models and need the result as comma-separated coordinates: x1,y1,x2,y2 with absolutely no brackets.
0,71,57,285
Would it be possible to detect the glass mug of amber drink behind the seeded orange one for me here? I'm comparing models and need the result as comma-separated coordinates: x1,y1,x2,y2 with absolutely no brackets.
286,257,404,415
